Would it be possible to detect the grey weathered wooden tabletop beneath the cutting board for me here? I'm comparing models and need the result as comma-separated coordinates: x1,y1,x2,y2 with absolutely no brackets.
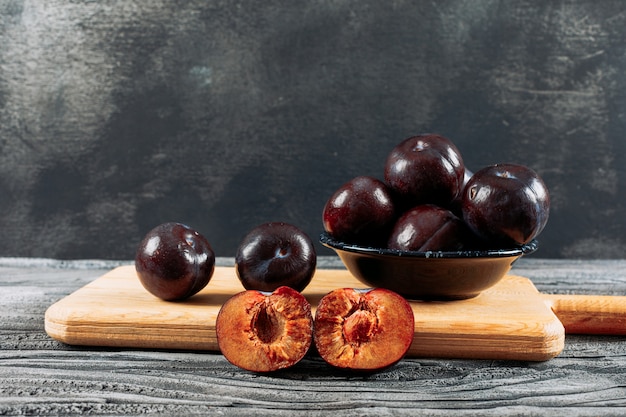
0,258,626,416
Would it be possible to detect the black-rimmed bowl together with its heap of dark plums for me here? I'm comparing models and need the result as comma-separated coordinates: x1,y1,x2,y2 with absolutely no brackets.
320,134,550,300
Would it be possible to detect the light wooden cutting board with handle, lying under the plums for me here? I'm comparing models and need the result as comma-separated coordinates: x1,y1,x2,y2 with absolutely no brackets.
45,265,626,361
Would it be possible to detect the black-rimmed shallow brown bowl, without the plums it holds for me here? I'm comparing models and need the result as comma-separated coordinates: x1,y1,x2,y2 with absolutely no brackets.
320,233,538,300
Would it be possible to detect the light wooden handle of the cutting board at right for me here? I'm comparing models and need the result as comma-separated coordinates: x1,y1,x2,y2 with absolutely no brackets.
543,294,626,335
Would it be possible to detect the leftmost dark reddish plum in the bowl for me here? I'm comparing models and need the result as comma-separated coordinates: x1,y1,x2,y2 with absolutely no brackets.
322,176,396,245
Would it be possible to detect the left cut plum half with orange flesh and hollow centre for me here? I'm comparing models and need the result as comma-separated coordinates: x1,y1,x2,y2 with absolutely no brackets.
215,287,313,372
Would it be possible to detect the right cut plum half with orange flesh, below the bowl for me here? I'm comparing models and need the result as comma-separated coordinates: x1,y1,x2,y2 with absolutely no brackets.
313,288,415,371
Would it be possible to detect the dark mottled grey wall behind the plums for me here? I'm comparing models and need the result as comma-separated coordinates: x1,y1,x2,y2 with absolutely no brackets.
0,0,626,259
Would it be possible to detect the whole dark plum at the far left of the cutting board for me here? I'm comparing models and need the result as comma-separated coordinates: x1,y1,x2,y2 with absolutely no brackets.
135,222,215,301
